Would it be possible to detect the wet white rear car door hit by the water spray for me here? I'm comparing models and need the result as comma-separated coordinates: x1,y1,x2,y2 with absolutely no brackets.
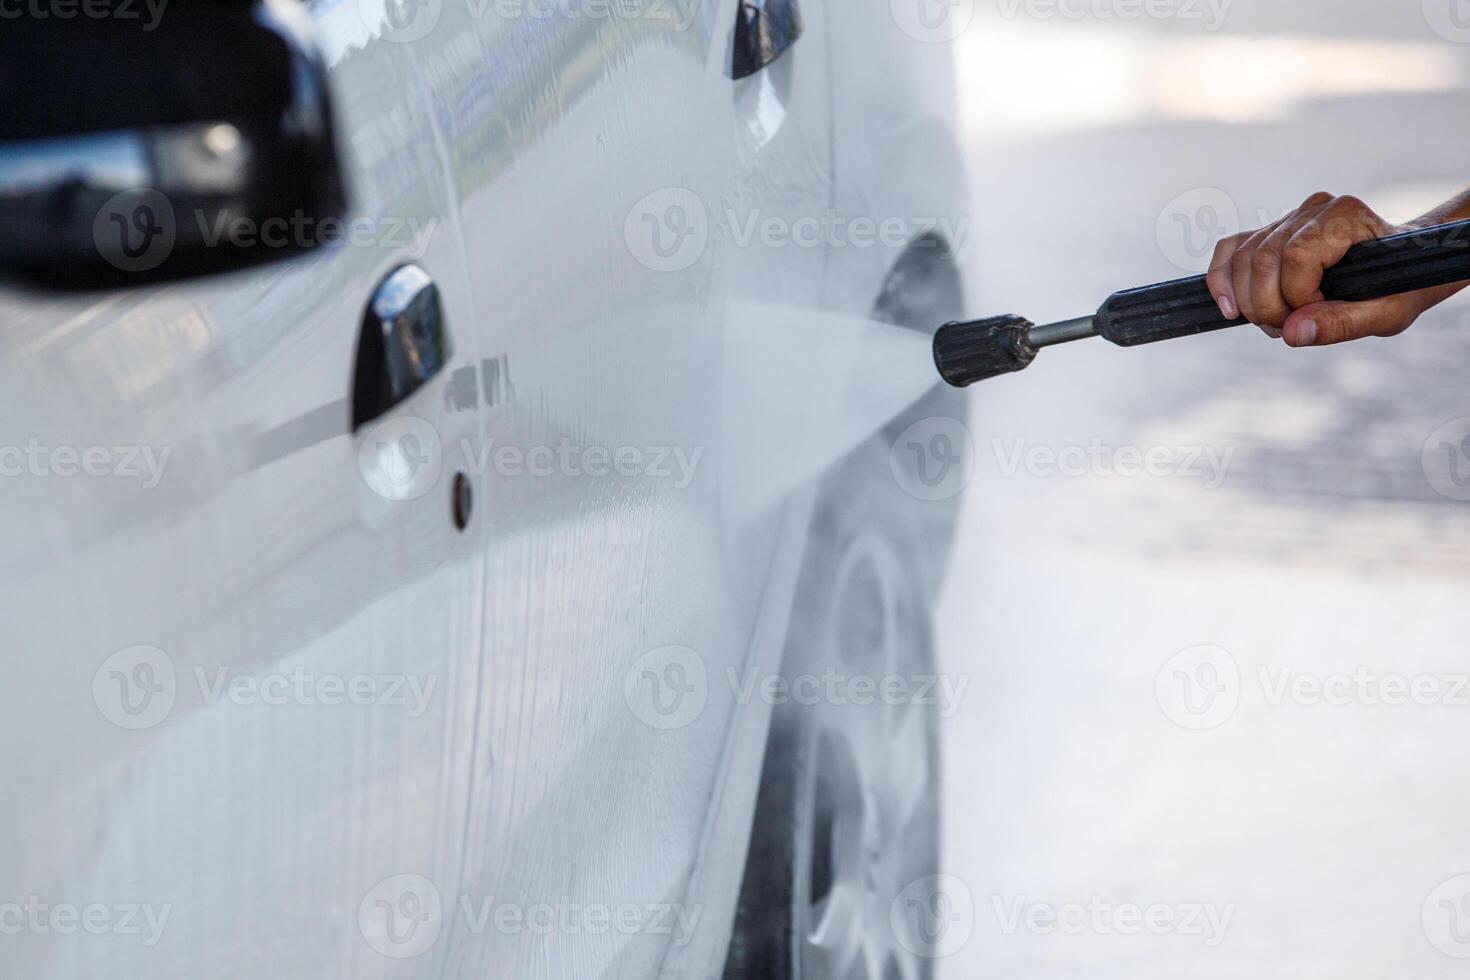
402,0,831,979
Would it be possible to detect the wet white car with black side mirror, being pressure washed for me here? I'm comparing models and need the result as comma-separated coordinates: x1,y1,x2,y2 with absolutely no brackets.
0,0,966,980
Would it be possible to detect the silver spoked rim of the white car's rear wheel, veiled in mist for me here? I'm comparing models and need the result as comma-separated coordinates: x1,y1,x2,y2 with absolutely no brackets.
792,533,939,980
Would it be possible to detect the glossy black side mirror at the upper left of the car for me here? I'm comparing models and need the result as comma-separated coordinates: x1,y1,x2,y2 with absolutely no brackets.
0,0,345,289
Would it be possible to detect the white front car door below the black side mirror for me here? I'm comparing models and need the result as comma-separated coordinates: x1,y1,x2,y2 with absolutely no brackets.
0,15,485,980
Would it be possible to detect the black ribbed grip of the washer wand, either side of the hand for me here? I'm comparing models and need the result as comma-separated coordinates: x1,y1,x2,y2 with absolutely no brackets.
1097,222,1470,347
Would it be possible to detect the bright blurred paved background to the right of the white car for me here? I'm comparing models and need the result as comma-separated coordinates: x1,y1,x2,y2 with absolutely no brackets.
939,0,1470,980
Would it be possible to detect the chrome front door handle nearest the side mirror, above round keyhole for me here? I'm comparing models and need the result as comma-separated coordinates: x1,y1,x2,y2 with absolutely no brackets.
353,266,454,432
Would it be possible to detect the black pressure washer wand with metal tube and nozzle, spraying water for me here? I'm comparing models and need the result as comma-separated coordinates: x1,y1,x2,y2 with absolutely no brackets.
933,220,1470,388
